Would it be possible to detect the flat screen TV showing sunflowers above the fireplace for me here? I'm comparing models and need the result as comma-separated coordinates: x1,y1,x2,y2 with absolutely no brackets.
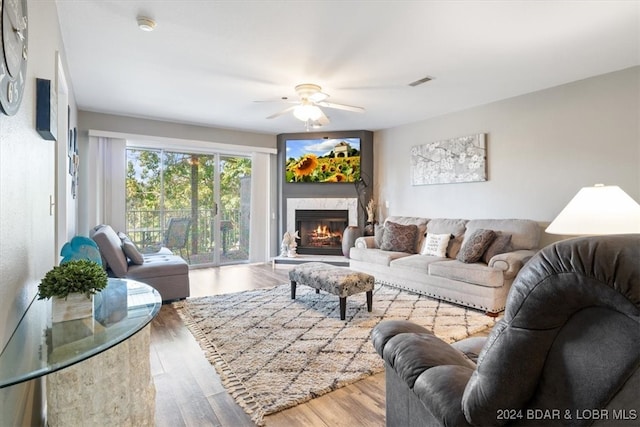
285,138,360,183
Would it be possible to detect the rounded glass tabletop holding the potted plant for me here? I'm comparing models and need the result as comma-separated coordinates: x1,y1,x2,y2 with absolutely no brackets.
0,279,162,388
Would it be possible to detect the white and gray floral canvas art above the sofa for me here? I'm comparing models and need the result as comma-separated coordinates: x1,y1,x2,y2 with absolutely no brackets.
411,133,487,185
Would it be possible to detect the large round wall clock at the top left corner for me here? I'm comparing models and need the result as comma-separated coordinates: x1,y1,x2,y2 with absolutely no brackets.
0,0,28,116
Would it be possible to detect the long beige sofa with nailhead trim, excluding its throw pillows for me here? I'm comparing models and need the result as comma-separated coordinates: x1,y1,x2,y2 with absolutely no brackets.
349,216,541,315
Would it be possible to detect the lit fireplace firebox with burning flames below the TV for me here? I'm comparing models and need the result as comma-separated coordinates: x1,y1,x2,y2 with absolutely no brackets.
295,209,349,255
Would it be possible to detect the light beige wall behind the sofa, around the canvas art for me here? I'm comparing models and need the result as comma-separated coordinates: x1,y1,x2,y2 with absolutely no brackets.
374,67,640,247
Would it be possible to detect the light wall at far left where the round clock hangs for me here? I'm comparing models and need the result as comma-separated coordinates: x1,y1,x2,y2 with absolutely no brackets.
0,1,75,426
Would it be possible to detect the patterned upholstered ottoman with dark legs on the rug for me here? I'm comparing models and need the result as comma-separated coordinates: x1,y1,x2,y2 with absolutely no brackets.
289,262,374,320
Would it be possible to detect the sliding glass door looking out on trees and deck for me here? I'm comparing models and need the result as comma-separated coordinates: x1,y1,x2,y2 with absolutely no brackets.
126,148,251,266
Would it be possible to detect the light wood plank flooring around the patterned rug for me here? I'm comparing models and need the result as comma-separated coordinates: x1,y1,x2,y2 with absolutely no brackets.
151,264,385,427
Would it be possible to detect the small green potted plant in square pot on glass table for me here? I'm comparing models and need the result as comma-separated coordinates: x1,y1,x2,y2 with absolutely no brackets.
38,259,107,322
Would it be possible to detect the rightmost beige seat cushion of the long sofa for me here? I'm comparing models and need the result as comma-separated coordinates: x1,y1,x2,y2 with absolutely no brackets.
429,260,504,288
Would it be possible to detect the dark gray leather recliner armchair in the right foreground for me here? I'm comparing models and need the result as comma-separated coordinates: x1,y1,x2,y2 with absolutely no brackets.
372,234,640,427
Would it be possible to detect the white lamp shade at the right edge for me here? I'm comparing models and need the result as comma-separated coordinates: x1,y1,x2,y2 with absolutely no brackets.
546,185,640,236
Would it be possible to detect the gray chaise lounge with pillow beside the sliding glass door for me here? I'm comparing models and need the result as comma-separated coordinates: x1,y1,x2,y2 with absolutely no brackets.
90,225,189,302
